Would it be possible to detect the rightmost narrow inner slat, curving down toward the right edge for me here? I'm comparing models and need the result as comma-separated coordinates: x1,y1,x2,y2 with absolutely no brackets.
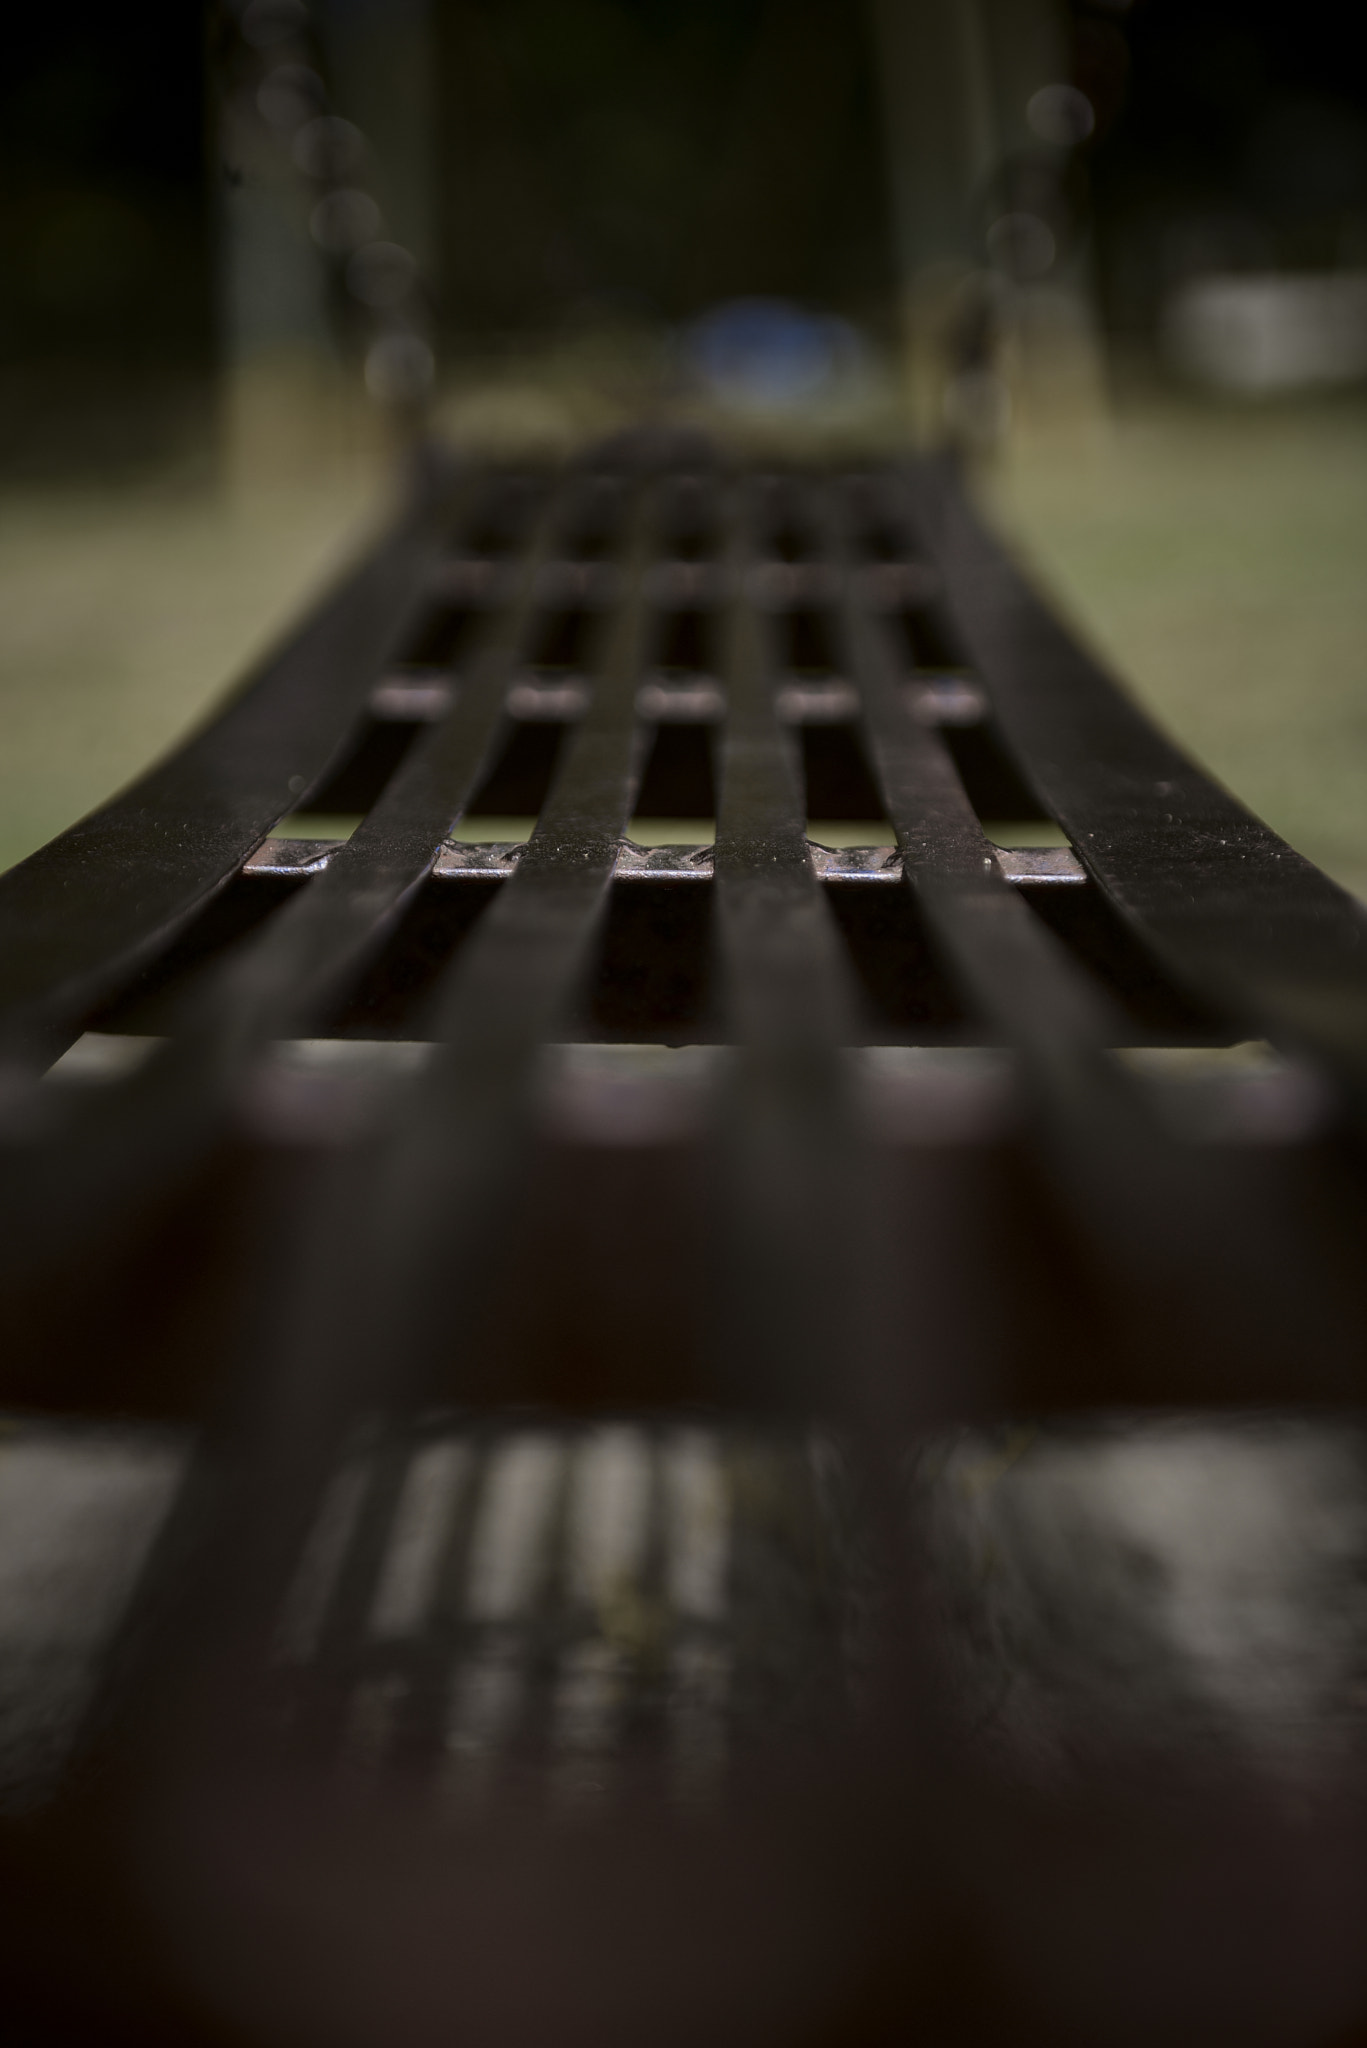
826,479,1365,1399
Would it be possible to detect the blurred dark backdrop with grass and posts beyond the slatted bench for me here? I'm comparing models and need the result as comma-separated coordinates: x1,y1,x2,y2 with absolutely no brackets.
0,0,1367,895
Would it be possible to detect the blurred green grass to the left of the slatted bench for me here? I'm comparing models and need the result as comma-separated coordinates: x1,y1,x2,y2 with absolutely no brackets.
0,475,375,868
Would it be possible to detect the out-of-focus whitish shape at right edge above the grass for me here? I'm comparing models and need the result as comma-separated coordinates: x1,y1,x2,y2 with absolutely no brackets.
1162,270,1367,393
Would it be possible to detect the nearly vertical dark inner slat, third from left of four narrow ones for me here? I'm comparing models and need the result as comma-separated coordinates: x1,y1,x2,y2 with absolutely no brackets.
713,468,869,1405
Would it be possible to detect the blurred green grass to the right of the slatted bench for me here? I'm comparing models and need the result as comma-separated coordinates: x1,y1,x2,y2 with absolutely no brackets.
986,395,1367,897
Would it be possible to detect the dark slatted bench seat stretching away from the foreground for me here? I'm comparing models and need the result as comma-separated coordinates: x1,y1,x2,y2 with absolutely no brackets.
0,432,1367,2048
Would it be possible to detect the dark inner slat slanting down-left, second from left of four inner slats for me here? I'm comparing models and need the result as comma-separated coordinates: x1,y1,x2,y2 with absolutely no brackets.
96,464,668,1745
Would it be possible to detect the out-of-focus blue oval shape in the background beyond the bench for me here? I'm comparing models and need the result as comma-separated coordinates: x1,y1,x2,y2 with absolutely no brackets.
685,299,863,412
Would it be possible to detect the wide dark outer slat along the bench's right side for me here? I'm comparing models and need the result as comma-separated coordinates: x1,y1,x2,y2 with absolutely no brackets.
902,465,1367,1094
